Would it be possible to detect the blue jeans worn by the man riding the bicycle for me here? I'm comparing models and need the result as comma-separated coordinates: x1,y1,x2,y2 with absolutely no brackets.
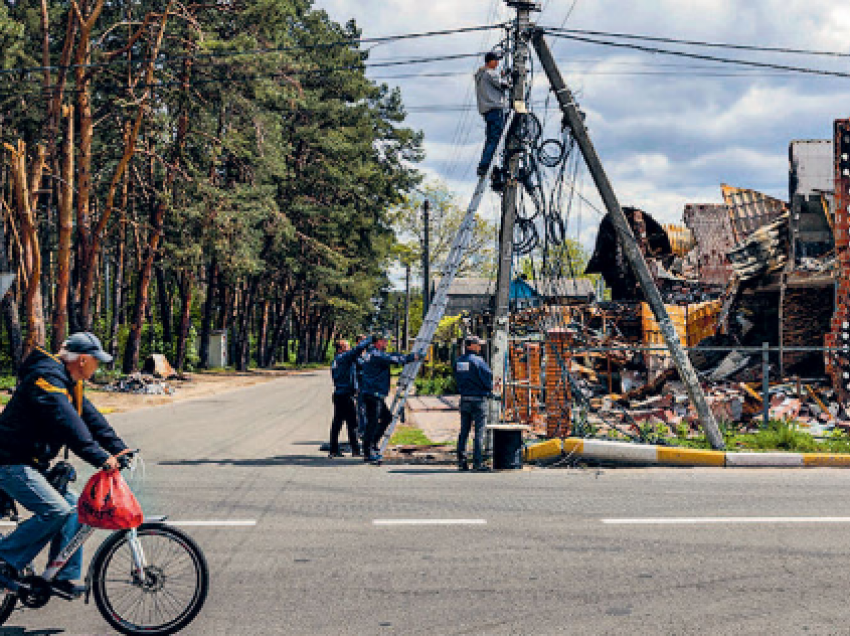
0,464,83,581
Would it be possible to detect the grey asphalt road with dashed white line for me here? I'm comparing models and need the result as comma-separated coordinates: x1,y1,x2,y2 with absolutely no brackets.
0,372,850,635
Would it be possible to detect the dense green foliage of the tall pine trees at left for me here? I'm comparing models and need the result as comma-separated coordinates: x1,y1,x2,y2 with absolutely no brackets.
0,0,423,368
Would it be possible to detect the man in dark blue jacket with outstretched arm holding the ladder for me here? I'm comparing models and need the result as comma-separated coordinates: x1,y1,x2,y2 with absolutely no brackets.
360,333,422,462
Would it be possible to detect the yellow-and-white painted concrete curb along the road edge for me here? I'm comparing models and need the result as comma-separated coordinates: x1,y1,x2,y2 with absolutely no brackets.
525,437,850,468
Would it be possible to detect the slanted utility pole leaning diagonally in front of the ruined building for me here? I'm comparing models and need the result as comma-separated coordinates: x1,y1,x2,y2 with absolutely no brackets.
532,30,725,449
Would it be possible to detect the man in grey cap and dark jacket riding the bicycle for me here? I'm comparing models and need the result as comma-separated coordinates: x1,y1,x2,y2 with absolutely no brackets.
0,332,127,598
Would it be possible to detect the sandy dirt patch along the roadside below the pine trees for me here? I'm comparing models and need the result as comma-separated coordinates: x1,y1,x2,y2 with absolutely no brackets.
86,369,315,414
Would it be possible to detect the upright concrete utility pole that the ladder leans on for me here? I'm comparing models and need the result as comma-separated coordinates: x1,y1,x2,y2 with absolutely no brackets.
487,0,540,424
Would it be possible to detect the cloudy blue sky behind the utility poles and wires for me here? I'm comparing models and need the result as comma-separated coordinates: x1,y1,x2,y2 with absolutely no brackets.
316,0,850,253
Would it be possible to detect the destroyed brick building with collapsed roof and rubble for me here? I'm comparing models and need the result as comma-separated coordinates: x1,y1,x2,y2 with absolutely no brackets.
506,120,850,436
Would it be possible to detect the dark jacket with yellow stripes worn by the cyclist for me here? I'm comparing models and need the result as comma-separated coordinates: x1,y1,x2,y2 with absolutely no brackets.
0,348,127,469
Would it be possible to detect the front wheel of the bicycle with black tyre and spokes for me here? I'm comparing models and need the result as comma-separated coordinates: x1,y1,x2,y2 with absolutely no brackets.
92,524,209,634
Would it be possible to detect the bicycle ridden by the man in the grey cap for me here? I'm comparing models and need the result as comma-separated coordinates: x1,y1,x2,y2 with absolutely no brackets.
0,451,209,635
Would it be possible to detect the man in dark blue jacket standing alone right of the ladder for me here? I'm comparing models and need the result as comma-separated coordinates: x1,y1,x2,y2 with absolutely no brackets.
454,336,493,472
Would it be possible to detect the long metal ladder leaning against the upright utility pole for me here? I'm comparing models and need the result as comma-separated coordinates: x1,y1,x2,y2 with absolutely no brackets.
380,111,514,455
